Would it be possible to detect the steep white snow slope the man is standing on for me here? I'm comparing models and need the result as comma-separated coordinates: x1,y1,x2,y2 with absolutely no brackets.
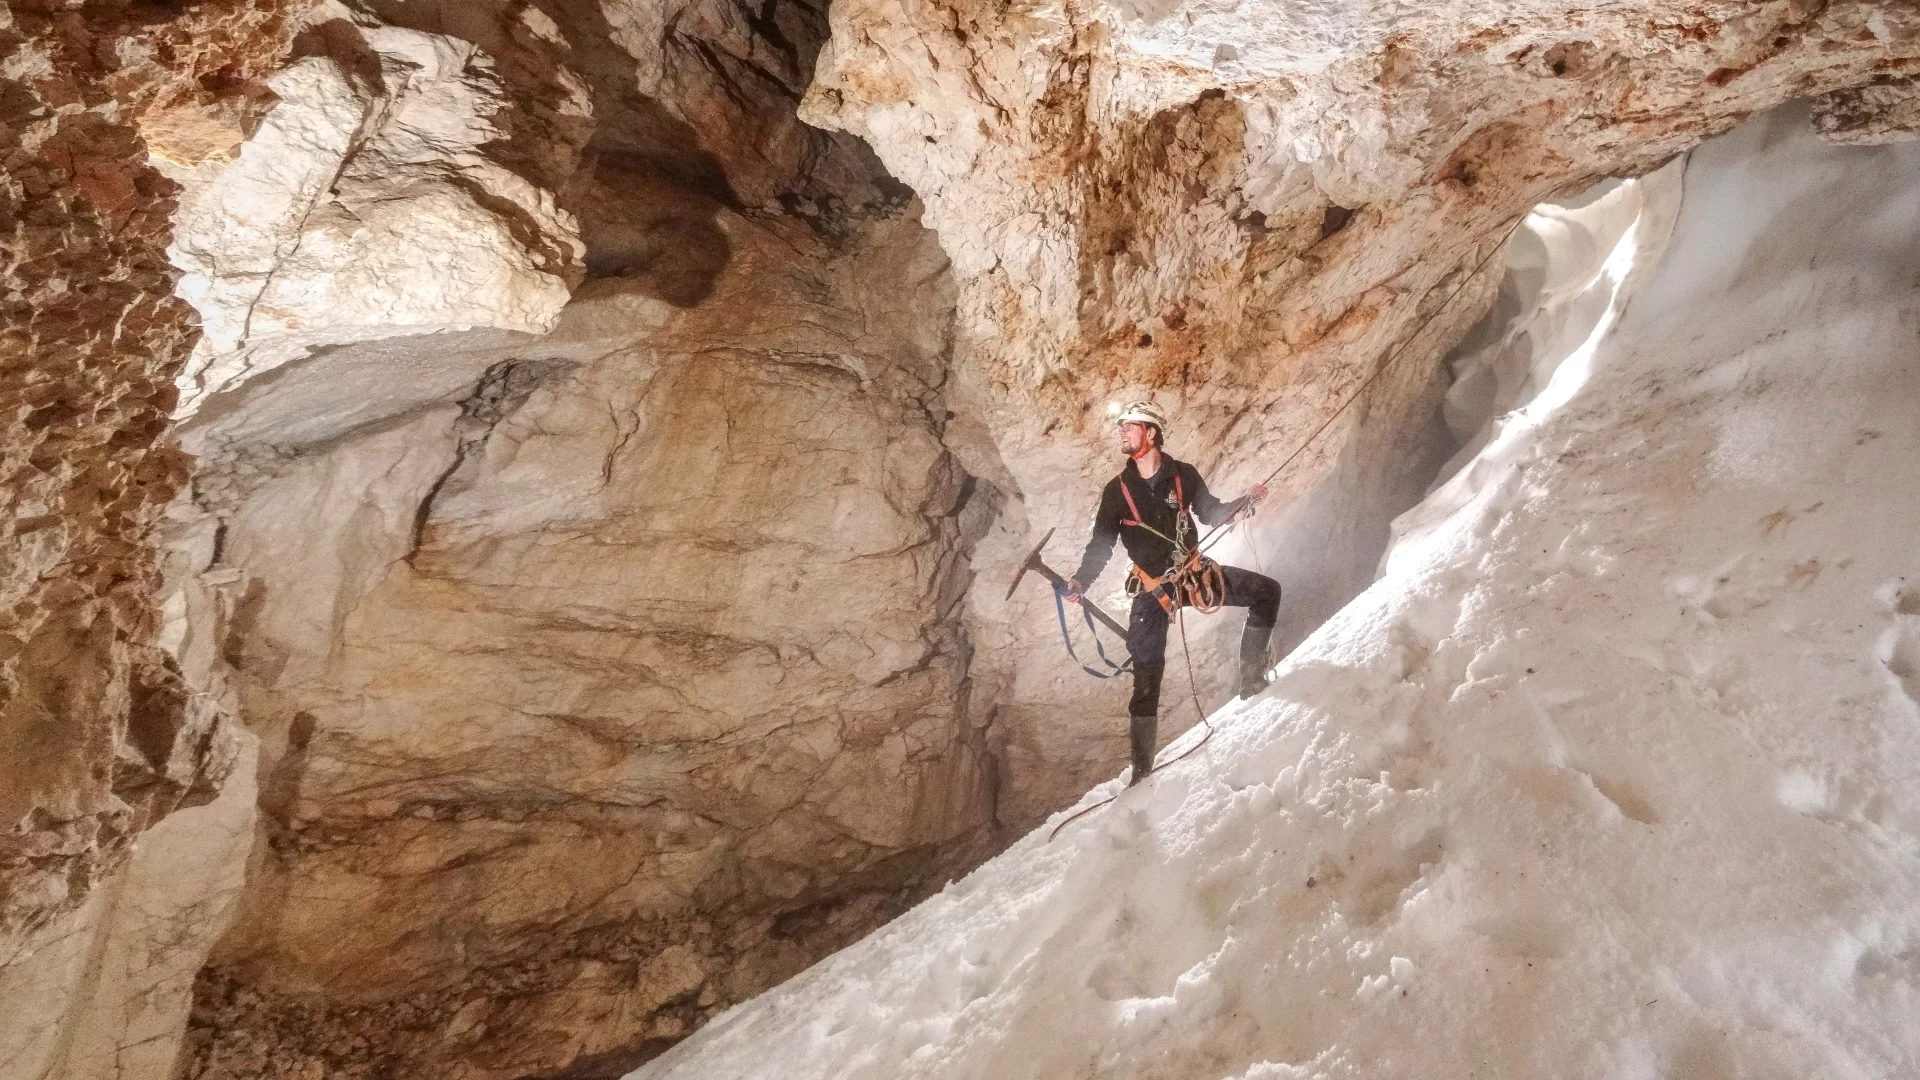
634,111,1920,1080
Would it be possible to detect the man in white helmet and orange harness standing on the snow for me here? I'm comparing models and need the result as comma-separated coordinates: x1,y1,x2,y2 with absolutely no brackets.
1066,402,1281,786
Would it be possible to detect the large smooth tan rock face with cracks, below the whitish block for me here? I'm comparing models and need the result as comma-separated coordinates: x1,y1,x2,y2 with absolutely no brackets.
180,215,995,1076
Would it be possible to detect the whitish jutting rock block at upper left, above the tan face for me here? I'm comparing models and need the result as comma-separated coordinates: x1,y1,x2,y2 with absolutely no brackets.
163,4,591,413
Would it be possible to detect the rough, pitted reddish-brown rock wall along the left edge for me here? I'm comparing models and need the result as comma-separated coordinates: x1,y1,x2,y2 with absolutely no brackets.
0,0,286,1080
